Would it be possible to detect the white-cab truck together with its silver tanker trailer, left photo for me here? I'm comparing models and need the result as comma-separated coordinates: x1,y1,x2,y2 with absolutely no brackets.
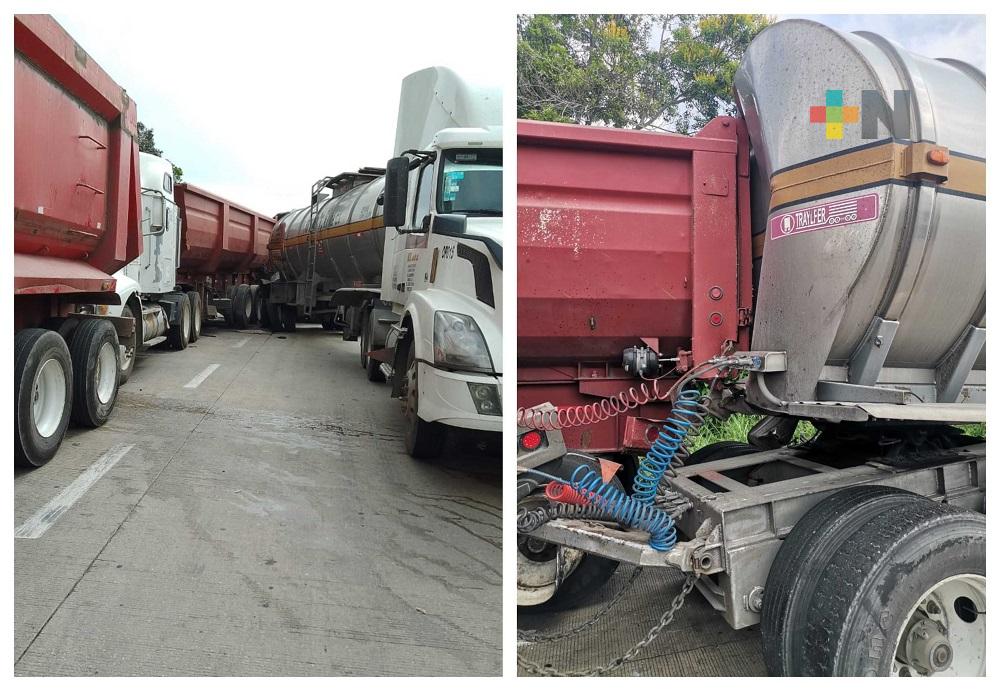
261,67,503,458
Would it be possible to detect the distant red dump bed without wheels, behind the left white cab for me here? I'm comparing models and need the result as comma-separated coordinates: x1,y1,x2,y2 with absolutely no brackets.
174,183,275,282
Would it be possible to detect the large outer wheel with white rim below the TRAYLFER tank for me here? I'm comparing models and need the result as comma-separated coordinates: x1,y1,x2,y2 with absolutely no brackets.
803,499,986,676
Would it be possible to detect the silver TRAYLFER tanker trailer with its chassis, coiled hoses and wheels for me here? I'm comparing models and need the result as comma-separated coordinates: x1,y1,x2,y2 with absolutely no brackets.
518,20,986,676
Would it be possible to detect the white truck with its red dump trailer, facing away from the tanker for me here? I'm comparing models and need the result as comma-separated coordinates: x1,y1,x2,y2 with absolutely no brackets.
106,153,274,383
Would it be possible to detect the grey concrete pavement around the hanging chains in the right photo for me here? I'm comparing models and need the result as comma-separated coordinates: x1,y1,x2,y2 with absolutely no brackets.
518,566,767,677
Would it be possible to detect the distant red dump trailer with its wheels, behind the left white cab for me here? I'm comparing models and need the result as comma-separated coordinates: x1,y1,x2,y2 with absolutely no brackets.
174,183,275,328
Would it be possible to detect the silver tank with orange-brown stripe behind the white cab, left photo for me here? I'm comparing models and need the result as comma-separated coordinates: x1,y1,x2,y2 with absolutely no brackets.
268,173,385,293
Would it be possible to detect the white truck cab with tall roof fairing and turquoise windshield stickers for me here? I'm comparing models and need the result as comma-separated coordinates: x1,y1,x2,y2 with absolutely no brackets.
374,67,503,456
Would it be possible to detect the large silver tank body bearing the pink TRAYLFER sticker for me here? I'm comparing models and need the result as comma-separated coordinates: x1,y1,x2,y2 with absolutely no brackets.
735,19,986,410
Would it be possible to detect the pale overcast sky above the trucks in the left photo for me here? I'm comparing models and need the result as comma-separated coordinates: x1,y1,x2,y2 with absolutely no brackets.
54,2,504,214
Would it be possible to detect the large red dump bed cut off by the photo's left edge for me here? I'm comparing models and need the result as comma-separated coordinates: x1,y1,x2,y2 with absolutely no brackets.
14,15,142,302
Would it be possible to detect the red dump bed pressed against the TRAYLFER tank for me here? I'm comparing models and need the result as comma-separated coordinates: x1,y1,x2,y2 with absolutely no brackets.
517,117,752,452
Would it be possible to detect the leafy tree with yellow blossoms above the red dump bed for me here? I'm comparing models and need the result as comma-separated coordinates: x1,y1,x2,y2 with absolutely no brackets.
517,14,773,133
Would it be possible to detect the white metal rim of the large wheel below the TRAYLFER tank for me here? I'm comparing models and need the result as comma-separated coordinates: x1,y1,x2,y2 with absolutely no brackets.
892,574,986,677
